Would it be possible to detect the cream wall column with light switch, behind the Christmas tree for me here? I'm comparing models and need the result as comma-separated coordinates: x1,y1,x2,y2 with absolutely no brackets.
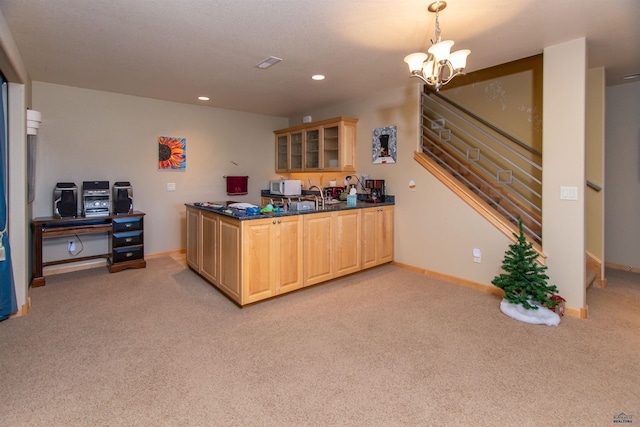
542,38,587,308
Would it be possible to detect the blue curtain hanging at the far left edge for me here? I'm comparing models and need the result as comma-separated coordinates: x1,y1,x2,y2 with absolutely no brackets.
0,74,18,321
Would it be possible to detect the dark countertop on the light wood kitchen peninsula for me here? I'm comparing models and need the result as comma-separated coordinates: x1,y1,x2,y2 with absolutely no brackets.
185,192,395,221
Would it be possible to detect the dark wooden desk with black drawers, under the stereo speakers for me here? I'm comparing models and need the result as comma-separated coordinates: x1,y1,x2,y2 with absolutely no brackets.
31,211,147,287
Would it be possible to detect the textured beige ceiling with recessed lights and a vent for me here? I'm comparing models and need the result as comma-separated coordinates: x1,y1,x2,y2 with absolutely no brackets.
0,0,640,117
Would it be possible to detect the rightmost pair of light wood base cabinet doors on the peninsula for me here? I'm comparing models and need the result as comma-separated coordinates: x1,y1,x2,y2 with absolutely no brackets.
362,206,394,268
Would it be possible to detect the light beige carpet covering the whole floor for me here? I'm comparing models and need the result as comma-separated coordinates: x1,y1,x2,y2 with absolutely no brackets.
0,257,640,426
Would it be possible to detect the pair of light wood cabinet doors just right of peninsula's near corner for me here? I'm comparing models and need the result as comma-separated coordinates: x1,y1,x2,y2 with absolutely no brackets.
242,215,302,304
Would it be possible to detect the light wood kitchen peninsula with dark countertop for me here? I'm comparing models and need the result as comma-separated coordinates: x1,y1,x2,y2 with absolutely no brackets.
186,196,395,306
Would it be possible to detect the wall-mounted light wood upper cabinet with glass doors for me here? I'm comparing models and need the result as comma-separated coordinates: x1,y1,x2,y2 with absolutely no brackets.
274,117,358,172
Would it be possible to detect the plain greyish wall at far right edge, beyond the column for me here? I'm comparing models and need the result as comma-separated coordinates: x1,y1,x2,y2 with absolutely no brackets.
605,78,640,271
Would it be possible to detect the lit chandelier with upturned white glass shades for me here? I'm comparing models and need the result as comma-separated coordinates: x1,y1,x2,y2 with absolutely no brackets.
404,1,471,91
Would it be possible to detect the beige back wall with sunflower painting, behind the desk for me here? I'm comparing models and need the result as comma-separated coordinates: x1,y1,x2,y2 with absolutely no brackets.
33,82,287,257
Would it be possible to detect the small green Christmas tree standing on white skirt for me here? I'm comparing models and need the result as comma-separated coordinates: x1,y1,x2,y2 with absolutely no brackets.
491,219,560,310
